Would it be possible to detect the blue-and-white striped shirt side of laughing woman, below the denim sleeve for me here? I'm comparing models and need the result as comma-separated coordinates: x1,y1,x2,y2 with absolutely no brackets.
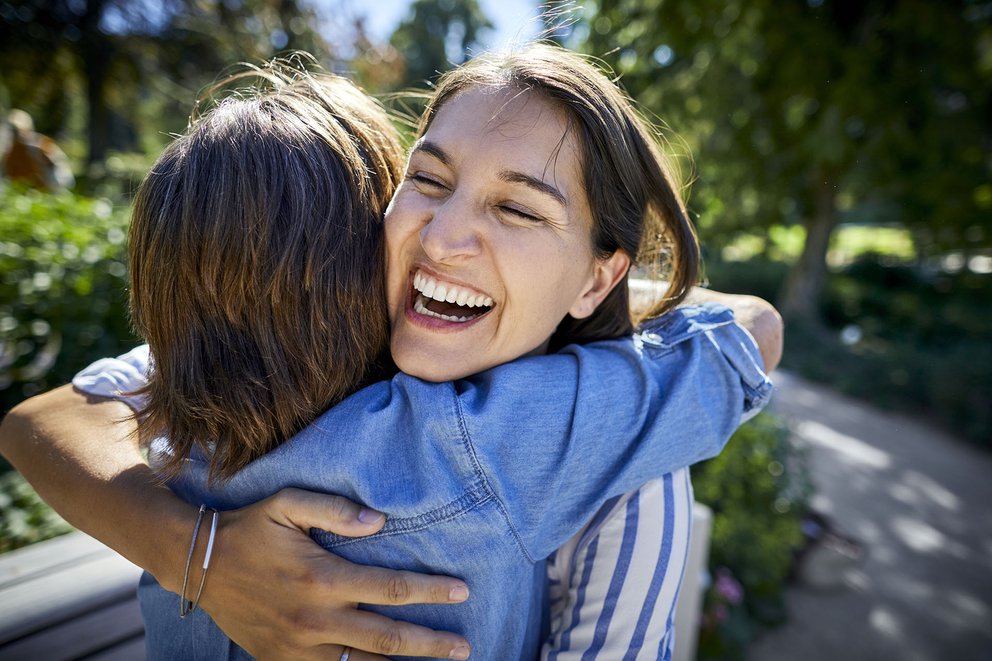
541,468,693,661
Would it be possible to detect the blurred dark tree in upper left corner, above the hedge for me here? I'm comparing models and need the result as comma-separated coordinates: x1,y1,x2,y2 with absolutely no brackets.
0,0,328,188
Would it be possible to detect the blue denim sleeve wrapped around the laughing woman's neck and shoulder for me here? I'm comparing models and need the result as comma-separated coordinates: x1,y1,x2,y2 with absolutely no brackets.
459,305,771,559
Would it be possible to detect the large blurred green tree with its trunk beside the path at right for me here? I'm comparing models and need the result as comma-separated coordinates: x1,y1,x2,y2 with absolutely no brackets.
566,0,992,319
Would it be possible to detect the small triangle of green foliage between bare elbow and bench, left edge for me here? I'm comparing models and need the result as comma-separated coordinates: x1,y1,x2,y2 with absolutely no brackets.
0,471,72,553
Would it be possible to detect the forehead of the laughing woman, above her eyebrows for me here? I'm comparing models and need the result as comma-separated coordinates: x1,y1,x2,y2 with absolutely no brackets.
424,88,582,186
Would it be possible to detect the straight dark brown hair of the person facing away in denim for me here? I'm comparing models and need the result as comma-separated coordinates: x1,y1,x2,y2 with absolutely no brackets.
129,63,403,479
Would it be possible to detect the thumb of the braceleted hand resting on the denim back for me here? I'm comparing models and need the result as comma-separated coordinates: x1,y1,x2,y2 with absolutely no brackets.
271,489,386,537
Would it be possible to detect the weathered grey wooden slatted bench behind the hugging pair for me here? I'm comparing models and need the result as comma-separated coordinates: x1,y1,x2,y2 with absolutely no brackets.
0,503,712,661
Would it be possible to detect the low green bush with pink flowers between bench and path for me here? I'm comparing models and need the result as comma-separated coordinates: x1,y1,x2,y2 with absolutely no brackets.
692,413,812,659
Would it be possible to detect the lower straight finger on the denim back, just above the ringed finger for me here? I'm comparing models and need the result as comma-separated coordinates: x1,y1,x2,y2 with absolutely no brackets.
341,610,471,659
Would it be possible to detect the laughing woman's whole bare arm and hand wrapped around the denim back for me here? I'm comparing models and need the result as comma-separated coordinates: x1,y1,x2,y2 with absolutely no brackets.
0,386,466,659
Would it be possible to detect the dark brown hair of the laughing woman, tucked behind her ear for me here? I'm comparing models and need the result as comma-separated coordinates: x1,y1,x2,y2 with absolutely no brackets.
418,43,699,350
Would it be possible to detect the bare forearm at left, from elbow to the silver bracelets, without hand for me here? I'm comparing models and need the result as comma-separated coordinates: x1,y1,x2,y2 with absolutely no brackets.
0,386,195,589
